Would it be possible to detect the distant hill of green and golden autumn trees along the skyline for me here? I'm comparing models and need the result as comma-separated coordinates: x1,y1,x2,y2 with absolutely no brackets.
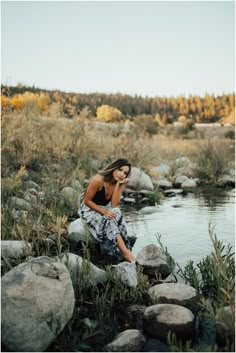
1,85,235,124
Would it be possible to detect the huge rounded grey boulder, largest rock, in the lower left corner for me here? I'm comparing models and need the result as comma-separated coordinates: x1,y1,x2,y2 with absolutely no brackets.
1,257,75,352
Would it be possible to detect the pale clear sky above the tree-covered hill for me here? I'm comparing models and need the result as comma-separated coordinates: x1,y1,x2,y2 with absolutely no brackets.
1,1,235,97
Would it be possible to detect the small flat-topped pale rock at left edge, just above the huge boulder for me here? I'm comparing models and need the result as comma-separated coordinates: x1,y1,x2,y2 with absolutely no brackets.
1,240,32,259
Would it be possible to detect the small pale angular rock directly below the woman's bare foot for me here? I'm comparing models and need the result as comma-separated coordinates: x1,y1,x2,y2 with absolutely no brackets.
111,261,138,287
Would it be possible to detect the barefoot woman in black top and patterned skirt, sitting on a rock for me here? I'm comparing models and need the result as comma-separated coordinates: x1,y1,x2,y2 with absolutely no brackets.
79,158,135,262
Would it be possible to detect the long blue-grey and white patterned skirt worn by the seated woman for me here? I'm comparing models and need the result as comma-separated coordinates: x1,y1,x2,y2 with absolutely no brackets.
78,202,132,260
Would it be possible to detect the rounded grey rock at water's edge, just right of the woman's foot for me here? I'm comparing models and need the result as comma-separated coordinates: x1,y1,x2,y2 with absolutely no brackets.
136,244,171,278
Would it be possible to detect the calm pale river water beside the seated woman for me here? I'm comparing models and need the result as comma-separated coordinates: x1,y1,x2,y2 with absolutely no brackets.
123,189,235,266
